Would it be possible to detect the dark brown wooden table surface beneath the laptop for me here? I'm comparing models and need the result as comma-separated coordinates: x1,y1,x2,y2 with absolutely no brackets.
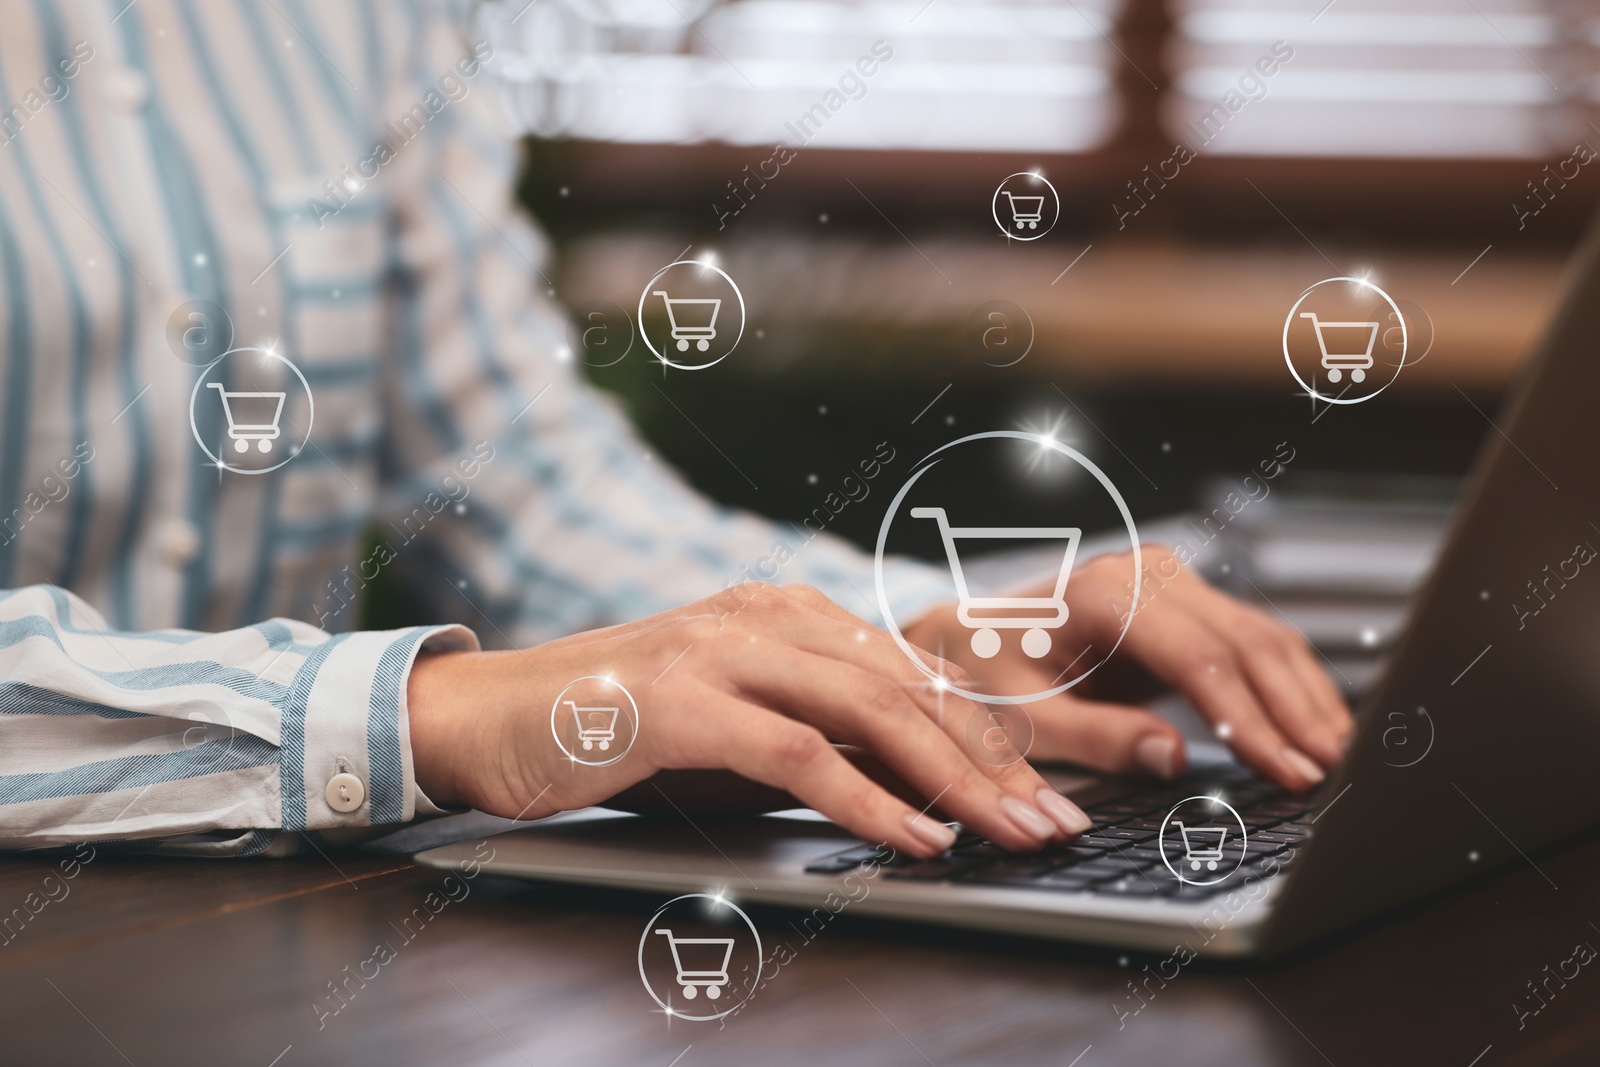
0,812,1600,1067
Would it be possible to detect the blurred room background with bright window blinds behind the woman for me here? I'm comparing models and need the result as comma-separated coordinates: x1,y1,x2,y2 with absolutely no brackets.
460,0,1600,646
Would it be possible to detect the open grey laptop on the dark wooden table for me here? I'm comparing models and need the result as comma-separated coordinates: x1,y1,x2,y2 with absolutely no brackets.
418,207,1600,958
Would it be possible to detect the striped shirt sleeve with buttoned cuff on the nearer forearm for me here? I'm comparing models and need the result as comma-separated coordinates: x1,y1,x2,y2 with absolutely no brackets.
0,585,477,856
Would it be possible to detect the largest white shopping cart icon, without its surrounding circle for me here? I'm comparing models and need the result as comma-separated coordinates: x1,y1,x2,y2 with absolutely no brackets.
910,507,1083,659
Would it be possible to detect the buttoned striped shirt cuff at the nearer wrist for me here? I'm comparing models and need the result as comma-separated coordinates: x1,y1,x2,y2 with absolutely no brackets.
280,625,478,830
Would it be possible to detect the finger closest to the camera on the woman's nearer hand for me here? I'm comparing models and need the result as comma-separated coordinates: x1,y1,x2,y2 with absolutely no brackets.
658,683,955,857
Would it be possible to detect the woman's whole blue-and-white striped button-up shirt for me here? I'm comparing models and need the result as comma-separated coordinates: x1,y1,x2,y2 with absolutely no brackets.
0,0,949,854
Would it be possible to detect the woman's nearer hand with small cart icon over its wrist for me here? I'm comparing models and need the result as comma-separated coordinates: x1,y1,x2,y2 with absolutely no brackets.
406,582,1090,856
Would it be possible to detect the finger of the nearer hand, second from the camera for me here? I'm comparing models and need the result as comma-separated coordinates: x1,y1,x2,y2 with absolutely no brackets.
726,643,1088,849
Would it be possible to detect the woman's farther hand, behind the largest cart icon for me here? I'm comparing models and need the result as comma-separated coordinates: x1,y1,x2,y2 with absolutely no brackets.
904,545,1354,792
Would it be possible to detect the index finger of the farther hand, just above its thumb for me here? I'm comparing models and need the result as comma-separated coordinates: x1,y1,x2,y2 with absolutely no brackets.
1075,609,1325,792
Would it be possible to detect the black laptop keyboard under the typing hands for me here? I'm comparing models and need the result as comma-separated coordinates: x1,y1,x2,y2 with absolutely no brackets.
806,768,1318,901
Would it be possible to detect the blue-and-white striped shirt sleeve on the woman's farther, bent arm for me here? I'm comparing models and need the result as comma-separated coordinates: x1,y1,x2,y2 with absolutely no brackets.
379,8,950,645
